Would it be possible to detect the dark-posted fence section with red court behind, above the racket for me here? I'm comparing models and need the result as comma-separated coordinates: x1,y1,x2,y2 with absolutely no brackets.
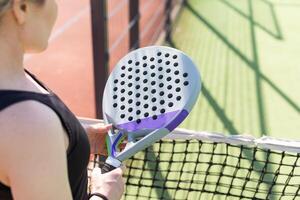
90,0,184,119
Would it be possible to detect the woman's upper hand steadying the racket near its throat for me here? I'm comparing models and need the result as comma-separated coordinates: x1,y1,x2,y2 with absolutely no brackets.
85,123,112,155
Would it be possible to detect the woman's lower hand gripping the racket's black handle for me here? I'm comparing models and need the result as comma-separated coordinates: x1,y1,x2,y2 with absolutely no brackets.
90,167,125,200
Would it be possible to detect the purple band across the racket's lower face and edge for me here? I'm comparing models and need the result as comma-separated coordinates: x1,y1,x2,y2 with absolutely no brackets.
116,110,188,132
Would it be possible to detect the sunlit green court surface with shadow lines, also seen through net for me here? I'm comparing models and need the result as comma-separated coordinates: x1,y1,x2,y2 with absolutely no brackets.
122,0,300,200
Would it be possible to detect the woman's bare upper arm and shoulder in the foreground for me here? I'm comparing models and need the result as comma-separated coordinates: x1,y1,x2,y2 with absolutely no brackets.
0,101,72,200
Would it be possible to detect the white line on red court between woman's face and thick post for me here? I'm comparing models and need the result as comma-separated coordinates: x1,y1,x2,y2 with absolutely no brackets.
24,5,90,61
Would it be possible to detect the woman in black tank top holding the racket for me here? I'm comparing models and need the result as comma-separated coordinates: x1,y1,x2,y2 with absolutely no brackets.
0,0,124,200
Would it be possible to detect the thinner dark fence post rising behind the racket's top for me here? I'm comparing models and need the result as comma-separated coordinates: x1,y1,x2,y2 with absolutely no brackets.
129,0,140,50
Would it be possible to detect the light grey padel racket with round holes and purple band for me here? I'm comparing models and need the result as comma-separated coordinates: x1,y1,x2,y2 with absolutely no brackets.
102,46,201,173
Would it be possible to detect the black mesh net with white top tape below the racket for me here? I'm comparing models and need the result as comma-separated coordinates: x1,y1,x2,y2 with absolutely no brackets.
123,129,300,200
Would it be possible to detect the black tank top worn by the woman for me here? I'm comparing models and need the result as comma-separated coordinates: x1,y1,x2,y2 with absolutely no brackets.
0,72,90,200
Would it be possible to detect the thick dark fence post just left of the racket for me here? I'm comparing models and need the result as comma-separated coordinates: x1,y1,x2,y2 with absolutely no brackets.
90,0,109,119
